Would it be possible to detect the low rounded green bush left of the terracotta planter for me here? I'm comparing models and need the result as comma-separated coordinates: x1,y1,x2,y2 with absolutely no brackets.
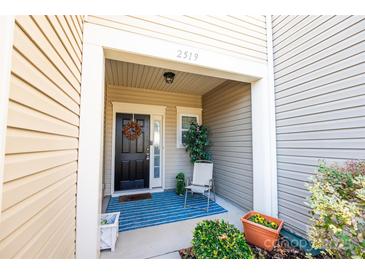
192,220,253,259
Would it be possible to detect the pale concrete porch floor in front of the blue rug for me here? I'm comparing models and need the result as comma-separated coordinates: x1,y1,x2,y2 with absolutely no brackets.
100,196,247,259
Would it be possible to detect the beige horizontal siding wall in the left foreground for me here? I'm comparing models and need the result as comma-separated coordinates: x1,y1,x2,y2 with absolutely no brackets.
0,16,83,258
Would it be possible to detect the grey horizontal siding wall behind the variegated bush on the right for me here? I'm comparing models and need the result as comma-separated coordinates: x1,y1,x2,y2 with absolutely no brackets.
273,16,365,236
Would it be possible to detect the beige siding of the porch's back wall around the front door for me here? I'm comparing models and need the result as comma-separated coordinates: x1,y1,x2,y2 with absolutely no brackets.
104,86,202,195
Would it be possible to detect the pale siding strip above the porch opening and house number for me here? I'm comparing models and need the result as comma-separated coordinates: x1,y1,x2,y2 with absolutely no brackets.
86,15,267,62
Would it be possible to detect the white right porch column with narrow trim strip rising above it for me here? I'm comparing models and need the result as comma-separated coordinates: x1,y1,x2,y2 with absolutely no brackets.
251,16,278,217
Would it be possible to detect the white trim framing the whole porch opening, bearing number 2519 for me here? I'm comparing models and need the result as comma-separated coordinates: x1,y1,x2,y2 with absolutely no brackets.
76,18,277,258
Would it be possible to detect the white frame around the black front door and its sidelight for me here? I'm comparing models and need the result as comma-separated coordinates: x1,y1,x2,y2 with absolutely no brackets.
110,101,166,196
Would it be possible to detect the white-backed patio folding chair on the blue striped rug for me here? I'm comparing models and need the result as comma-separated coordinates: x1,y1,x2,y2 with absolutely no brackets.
184,160,215,212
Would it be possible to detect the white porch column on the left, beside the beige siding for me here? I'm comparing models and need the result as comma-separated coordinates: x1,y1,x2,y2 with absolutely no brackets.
76,43,104,258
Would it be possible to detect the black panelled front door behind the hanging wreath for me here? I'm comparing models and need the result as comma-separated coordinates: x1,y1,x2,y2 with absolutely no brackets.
114,113,150,191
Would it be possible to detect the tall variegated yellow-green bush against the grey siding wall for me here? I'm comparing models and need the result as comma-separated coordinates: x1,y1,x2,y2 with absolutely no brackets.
309,161,365,259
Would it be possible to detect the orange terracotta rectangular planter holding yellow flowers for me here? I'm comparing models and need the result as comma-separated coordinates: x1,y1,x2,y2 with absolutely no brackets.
241,211,284,251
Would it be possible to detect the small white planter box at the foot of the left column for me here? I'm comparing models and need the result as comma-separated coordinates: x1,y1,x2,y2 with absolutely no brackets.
100,212,120,251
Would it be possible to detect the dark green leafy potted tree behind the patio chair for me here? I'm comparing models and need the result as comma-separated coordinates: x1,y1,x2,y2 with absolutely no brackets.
184,122,210,163
